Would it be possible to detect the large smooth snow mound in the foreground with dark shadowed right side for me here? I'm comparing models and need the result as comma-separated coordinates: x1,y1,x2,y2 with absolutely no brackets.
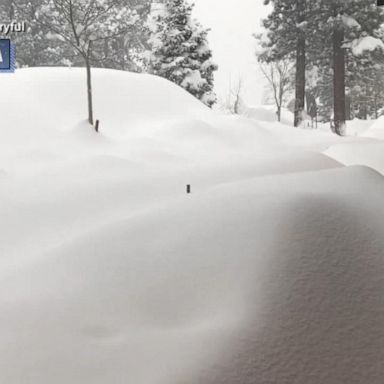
0,168,384,384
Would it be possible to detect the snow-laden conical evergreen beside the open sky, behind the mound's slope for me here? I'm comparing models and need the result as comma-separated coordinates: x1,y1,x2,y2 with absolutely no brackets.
149,0,217,107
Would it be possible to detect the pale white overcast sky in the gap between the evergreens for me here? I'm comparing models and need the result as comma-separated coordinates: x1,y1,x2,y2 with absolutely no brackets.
194,0,269,105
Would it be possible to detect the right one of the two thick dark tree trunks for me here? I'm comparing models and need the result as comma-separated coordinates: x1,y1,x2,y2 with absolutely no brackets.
333,23,345,136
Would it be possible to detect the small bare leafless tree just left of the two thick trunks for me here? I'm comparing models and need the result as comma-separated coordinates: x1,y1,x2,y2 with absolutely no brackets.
259,59,292,122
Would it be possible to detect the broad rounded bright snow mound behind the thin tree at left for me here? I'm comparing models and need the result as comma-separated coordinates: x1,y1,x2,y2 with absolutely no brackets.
0,68,210,138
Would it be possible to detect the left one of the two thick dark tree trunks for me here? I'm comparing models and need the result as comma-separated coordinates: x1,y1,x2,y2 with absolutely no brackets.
294,28,306,127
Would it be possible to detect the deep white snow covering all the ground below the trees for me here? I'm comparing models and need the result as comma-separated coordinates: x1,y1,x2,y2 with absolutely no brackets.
0,68,384,384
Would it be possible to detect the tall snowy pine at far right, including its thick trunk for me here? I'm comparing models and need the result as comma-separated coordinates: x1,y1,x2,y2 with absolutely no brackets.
313,0,384,135
